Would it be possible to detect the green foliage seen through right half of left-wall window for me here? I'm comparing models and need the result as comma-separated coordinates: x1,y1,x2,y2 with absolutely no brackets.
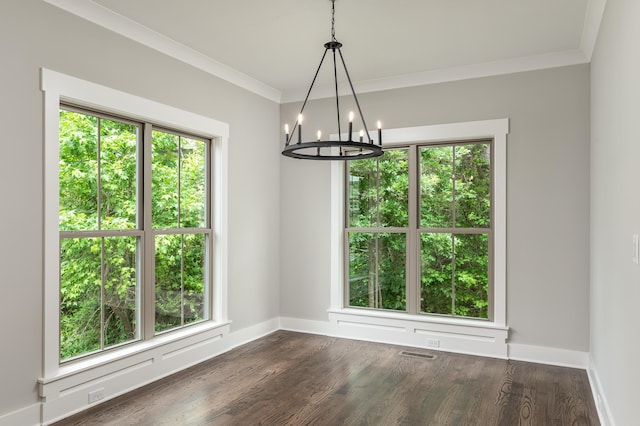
151,131,207,332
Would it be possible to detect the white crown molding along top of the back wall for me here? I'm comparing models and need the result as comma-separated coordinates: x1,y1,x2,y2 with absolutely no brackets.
282,50,589,103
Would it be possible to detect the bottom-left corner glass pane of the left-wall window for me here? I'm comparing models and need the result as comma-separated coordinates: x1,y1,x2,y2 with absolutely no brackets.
60,238,102,360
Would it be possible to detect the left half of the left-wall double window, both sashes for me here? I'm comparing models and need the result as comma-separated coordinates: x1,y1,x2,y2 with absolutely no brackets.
59,109,142,360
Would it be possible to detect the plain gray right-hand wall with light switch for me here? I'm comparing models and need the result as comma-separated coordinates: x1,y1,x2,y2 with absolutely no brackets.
591,0,640,425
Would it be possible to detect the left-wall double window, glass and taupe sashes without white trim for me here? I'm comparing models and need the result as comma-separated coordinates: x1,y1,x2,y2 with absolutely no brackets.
59,105,211,361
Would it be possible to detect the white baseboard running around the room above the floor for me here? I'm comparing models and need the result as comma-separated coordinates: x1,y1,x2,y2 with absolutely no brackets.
18,312,615,426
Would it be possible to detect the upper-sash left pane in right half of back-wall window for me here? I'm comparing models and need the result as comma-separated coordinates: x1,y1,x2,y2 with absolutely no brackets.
420,146,453,228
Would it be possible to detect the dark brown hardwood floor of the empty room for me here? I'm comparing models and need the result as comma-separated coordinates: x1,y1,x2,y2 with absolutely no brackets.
56,331,600,426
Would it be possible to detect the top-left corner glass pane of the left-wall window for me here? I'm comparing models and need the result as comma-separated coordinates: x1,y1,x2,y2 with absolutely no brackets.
59,110,98,231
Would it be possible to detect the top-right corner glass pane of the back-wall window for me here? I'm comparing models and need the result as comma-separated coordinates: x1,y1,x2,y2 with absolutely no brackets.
455,143,491,228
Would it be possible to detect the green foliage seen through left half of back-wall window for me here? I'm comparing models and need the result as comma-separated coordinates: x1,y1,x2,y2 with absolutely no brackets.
348,150,409,311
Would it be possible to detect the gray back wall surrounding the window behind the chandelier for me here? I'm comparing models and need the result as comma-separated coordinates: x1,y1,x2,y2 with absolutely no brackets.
280,65,590,352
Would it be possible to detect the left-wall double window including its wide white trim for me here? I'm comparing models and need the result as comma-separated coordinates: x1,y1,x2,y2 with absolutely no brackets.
39,69,230,382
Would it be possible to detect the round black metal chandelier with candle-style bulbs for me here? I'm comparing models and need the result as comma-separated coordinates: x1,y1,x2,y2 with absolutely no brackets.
282,0,383,160
